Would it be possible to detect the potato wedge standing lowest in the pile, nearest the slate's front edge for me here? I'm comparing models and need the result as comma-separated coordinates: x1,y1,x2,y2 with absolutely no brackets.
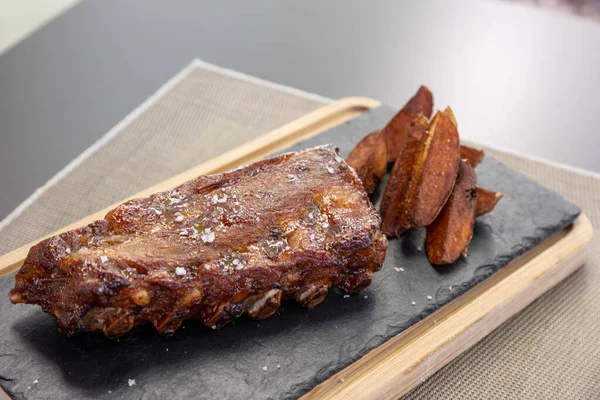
425,160,477,265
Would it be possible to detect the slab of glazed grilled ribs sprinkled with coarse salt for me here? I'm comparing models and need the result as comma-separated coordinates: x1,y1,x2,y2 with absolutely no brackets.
10,146,387,337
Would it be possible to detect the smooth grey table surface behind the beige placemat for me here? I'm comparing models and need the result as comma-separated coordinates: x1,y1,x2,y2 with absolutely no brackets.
0,0,600,222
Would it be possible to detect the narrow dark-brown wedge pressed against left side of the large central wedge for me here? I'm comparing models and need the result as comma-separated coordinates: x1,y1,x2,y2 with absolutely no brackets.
379,115,429,236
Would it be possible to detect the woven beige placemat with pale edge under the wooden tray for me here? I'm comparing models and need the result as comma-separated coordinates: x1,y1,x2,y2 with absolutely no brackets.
0,61,600,399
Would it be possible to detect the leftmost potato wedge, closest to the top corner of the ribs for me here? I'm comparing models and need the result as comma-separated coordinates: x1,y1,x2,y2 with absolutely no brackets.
346,129,387,194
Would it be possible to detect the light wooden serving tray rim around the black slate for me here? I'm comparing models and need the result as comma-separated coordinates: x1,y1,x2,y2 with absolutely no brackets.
0,97,592,399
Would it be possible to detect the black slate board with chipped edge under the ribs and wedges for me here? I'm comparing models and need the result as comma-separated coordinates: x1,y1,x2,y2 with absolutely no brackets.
0,107,580,399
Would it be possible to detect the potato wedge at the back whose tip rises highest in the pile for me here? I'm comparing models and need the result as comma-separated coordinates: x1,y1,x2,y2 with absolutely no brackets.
382,86,433,163
